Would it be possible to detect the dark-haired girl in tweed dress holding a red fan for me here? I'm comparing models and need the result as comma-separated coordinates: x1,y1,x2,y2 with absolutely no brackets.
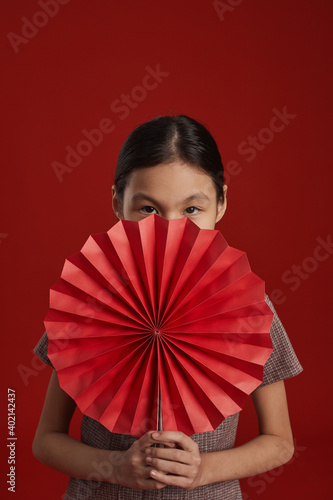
33,116,302,500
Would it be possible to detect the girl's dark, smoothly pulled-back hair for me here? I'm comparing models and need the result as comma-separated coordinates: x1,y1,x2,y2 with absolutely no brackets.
115,115,224,203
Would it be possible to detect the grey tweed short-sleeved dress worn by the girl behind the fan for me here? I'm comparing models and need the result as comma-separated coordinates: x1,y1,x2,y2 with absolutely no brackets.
35,295,303,500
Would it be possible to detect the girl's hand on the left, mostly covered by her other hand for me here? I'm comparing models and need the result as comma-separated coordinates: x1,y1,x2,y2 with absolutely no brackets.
111,431,175,490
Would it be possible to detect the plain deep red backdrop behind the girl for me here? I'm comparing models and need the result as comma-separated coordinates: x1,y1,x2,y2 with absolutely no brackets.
0,0,333,500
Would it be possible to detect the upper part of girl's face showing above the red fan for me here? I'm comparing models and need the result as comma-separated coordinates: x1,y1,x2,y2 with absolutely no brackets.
112,161,227,229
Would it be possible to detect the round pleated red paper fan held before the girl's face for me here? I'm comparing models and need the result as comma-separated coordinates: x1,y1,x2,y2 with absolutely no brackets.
45,215,273,437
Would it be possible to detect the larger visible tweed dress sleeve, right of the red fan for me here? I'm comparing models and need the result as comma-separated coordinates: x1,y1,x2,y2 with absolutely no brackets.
259,295,303,387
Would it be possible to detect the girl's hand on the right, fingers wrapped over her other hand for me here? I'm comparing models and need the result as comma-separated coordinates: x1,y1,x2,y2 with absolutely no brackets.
146,431,203,490
